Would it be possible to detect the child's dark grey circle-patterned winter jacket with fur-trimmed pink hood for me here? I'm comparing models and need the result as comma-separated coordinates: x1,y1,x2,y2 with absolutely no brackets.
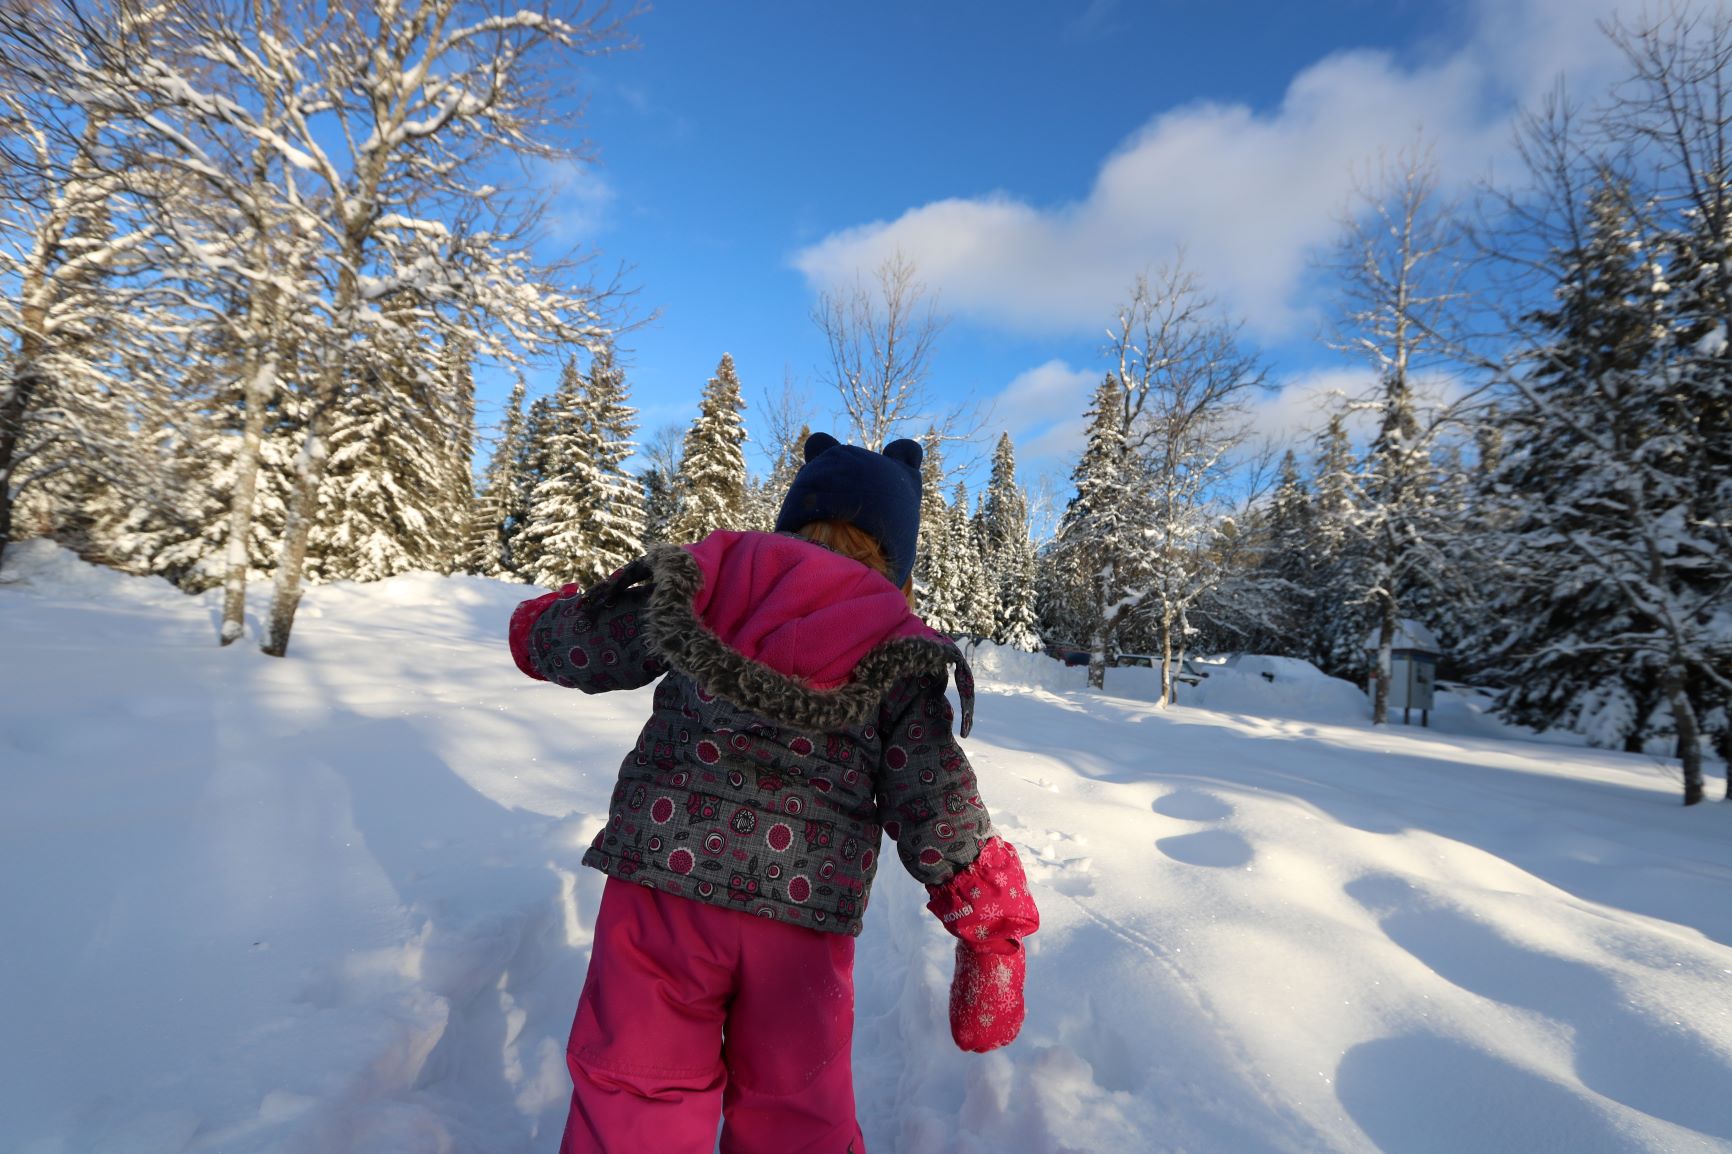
511,532,992,934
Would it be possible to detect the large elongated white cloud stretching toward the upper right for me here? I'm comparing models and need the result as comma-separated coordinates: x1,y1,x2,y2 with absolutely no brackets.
795,0,1611,338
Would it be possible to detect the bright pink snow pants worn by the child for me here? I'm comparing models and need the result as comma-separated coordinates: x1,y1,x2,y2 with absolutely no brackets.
559,877,866,1154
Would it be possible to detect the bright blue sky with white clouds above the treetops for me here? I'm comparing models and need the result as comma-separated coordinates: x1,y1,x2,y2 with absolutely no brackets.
483,0,1635,488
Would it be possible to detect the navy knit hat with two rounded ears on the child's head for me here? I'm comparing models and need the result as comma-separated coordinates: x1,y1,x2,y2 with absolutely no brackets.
776,433,921,586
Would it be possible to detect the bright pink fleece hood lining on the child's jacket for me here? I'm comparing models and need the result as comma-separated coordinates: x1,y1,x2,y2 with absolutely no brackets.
686,532,949,690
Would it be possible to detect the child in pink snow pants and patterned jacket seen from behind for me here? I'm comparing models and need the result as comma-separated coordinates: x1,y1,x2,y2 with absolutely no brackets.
511,433,1039,1154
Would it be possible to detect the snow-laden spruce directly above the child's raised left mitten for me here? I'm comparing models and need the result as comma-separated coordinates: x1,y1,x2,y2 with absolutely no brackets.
520,362,606,589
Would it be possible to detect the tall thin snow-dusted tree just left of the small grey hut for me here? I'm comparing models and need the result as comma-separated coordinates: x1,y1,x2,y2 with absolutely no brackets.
1332,149,1462,724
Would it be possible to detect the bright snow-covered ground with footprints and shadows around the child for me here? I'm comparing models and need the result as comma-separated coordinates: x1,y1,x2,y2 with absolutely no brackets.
10,542,1732,1154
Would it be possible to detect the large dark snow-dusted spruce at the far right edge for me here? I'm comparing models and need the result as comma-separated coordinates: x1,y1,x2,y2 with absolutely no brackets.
1493,168,1723,804
